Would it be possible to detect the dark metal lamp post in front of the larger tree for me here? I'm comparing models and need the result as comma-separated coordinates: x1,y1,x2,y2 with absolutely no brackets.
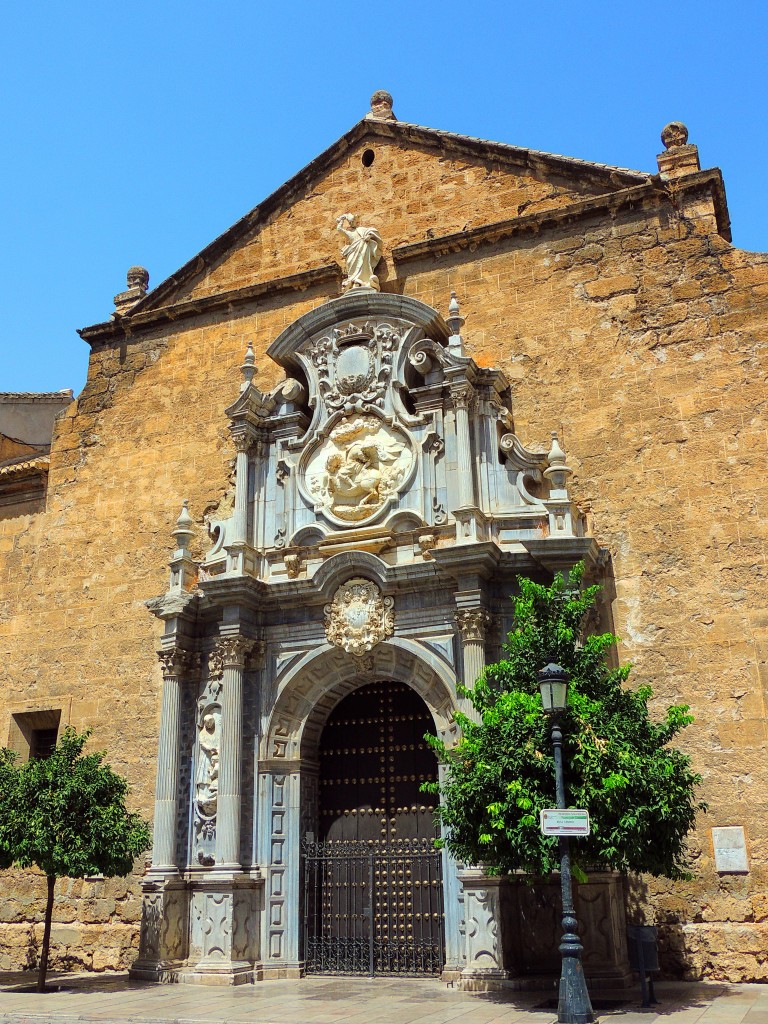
539,664,595,1024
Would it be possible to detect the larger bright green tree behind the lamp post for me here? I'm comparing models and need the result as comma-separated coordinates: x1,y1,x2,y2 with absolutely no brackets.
427,563,706,879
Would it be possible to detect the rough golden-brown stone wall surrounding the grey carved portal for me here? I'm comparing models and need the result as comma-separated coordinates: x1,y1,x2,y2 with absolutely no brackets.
0,123,768,980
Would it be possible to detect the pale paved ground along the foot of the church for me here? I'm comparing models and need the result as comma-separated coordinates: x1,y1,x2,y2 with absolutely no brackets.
0,974,768,1024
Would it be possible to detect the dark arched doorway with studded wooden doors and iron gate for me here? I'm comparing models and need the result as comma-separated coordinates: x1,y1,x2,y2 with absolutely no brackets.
303,681,444,975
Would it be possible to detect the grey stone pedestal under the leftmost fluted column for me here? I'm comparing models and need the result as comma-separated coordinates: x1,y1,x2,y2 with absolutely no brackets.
129,874,189,982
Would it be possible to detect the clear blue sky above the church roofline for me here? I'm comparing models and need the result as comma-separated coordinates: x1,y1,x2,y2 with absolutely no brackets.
0,0,768,393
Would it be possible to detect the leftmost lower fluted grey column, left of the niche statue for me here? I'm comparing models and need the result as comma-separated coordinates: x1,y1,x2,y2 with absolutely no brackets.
152,648,191,874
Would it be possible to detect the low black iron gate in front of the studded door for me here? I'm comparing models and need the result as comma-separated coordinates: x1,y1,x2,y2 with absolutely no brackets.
303,839,444,976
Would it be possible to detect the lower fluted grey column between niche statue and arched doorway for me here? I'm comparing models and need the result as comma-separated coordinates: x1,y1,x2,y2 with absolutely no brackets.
216,637,254,870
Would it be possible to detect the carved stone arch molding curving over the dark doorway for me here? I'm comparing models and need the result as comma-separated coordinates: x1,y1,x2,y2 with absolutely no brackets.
261,637,458,763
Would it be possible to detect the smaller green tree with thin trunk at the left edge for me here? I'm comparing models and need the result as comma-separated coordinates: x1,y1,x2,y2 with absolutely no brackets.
0,728,150,992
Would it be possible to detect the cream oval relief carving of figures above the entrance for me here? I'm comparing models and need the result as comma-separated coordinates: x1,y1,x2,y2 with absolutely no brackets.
306,416,414,522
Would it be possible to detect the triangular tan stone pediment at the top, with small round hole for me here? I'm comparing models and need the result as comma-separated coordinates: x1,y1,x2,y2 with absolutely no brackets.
130,118,649,315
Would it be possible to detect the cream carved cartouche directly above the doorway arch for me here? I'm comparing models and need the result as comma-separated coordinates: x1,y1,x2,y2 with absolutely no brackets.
325,578,394,657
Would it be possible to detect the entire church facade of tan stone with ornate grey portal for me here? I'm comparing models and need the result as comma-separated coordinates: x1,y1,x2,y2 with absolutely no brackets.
0,93,768,985
